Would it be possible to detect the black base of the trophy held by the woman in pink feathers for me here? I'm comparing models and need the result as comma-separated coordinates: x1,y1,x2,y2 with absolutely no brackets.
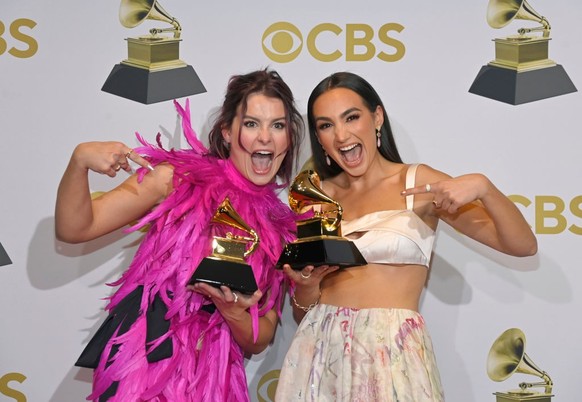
188,257,258,295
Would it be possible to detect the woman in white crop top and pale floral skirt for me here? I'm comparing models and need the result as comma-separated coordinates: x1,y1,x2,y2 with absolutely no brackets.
276,72,537,402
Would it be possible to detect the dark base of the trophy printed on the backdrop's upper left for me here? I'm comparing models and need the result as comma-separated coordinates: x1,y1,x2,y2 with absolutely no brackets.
101,63,206,105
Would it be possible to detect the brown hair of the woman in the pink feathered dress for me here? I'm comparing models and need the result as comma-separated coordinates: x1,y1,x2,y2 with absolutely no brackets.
208,69,304,183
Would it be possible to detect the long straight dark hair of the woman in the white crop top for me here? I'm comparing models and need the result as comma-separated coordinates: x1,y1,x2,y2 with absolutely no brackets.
307,72,402,178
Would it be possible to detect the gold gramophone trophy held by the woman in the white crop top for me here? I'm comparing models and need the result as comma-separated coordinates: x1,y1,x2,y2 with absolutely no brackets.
277,170,367,270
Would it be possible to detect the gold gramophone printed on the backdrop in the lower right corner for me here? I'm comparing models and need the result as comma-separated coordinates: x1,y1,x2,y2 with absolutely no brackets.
487,328,553,402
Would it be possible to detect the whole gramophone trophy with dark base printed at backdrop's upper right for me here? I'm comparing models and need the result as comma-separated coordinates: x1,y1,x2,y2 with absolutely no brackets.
469,0,577,105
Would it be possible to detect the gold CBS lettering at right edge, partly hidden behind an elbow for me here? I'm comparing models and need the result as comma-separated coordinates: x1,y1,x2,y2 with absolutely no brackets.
509,195,582,235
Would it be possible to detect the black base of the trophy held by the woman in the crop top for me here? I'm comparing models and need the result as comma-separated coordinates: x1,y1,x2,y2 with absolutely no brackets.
277,238,367,270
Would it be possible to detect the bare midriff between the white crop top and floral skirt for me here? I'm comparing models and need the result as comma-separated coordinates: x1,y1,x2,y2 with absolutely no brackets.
320,264,428,311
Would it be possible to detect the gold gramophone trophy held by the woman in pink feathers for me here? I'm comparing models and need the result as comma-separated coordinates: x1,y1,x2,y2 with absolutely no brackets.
188,197,259,294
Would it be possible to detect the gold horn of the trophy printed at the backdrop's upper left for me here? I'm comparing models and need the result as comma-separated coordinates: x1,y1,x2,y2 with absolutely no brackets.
119,0,182,39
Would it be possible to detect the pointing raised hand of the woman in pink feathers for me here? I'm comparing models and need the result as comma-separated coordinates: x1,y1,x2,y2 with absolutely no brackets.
71,141,153,177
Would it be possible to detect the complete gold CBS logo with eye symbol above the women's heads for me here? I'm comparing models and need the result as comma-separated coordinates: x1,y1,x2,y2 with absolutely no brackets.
262,21,406,63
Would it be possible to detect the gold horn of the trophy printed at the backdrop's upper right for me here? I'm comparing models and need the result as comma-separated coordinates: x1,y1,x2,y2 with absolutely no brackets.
487,0,551,38
